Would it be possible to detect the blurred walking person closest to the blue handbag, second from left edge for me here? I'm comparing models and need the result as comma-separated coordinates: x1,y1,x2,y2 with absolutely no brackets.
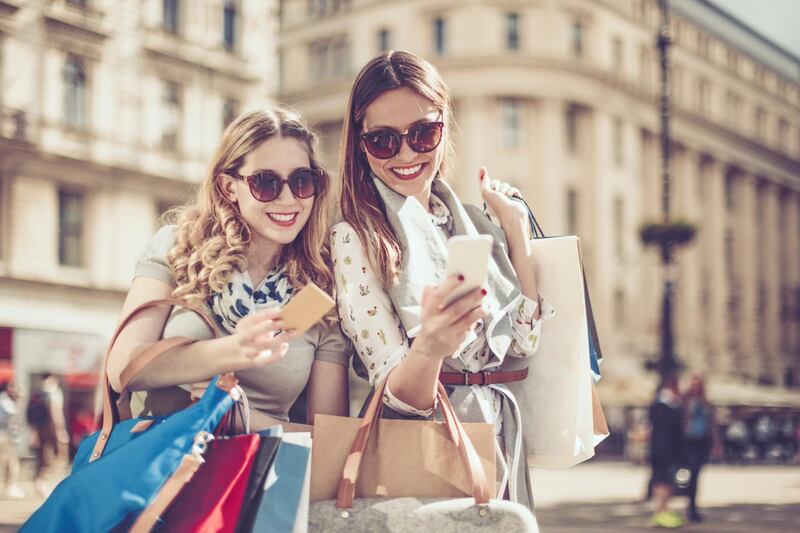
26,373,69,495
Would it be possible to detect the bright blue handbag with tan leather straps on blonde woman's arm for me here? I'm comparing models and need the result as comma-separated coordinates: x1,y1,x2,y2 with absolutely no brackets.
21,299,247,533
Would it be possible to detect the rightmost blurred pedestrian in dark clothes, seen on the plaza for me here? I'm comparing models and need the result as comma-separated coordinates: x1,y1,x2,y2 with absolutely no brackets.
683,376,721,522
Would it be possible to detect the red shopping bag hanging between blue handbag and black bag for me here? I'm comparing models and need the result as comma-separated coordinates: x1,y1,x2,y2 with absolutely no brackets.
163,434,261,533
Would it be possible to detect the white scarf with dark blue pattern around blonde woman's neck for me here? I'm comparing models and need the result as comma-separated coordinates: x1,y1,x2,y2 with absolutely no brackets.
208,267,293,333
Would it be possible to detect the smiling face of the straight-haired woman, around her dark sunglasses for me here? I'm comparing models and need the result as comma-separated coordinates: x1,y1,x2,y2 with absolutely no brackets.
361,87,447,204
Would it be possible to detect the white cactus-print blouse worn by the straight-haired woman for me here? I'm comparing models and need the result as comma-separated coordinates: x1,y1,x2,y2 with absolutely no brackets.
331,195,555,416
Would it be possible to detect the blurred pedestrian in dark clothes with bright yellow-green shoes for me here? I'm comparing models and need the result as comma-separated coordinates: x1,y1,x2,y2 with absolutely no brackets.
650,375,684,528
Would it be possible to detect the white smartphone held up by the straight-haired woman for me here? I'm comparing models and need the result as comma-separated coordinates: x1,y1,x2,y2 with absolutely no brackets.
444,235,494,306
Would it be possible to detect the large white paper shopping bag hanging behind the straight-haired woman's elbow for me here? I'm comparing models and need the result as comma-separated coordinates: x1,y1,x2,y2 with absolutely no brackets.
507,235,608,468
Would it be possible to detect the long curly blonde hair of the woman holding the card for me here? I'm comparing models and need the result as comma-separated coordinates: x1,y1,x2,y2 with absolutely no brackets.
167,106,334,312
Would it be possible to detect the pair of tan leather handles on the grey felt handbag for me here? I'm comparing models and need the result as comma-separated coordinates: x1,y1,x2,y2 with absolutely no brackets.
336,376,491,509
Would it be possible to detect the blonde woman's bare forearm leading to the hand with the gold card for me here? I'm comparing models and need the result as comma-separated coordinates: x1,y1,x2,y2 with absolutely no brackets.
128,335,252,390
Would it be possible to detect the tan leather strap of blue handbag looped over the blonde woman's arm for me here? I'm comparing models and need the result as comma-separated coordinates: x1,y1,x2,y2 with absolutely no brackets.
89,298,237,462
